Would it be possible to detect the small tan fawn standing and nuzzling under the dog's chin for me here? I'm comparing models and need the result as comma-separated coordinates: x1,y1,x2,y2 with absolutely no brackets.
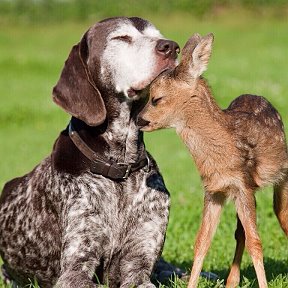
138,34,288,288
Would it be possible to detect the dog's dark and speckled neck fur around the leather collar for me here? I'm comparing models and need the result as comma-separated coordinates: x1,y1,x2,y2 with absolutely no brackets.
53,95,145,174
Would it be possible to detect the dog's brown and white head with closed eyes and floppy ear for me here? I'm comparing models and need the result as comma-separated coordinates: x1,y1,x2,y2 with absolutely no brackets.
53,17,179,126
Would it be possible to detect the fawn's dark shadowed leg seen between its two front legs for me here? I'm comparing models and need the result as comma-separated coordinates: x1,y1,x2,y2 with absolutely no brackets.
226,215,245,288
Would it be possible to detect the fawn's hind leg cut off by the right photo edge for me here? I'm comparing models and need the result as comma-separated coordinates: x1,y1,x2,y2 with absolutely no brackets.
273,175,288,236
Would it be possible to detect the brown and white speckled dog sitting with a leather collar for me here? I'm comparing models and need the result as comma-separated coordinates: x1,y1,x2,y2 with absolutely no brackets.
0,17,179,288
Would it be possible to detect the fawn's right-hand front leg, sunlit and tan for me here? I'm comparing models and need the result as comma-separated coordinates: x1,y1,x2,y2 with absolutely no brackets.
235,190,268,288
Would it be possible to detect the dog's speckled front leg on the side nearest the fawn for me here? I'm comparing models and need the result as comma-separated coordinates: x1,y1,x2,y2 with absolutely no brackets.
120,173,170,288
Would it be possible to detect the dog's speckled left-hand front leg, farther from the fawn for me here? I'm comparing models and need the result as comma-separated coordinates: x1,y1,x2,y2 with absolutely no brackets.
55,210,107,288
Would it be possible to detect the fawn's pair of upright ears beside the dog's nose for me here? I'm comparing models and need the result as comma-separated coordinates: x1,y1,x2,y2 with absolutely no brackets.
176,33,214,80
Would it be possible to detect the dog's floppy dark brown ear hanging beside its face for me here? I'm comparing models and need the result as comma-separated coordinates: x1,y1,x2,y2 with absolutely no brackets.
53,33,106,126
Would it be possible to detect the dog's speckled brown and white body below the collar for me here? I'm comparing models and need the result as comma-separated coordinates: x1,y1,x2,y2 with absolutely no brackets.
0,157,169,287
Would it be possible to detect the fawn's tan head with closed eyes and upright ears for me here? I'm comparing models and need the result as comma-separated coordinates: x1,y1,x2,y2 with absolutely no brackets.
138,33,214,131
